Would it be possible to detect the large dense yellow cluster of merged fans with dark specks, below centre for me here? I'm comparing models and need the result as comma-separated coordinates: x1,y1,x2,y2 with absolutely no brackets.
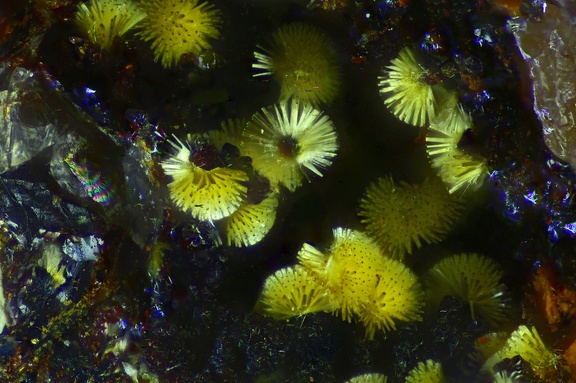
260,228,424,339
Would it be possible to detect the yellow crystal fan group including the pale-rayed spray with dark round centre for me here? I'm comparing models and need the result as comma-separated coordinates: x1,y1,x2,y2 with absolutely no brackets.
161,102,338,246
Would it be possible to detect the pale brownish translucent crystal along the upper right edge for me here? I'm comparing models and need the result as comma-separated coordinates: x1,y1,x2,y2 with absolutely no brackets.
512,3,576,169
